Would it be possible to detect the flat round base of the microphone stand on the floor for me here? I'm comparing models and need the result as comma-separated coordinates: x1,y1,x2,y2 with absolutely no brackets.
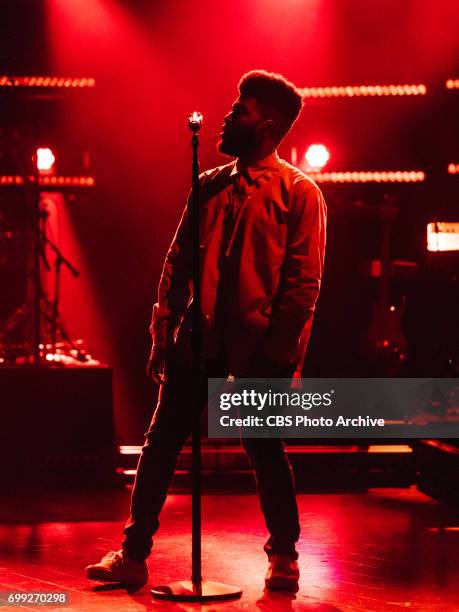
151,580,242,601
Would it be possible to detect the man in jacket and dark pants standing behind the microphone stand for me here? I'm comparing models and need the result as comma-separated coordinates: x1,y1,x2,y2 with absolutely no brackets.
87,71,326,590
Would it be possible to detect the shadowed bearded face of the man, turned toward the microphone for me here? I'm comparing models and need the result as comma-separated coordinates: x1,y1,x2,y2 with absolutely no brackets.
218,98,265,157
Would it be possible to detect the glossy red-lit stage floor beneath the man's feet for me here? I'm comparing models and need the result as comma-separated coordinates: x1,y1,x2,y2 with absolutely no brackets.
0,488,459,612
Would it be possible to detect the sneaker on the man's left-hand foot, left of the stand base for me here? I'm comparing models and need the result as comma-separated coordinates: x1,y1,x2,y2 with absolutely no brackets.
86,550,148,584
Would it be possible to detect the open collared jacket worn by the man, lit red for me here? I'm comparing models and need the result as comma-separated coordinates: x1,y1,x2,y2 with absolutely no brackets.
150,153,326,376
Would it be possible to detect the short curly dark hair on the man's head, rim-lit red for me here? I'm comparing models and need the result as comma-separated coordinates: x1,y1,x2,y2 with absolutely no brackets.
238,70,303,142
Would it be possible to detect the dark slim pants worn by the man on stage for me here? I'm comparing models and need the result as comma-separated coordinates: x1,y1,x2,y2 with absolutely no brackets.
123,352,300,561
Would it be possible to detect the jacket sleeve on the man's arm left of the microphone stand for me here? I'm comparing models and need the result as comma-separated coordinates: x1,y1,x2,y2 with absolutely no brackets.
150,190,192,348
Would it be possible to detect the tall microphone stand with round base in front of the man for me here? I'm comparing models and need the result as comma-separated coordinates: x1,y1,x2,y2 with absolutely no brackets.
151,112,242,601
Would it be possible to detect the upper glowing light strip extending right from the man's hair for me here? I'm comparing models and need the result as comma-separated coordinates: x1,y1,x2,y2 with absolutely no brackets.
300,83,427,98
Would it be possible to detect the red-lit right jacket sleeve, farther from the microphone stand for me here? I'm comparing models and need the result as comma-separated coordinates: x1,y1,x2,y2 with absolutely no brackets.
259,178,327,363
